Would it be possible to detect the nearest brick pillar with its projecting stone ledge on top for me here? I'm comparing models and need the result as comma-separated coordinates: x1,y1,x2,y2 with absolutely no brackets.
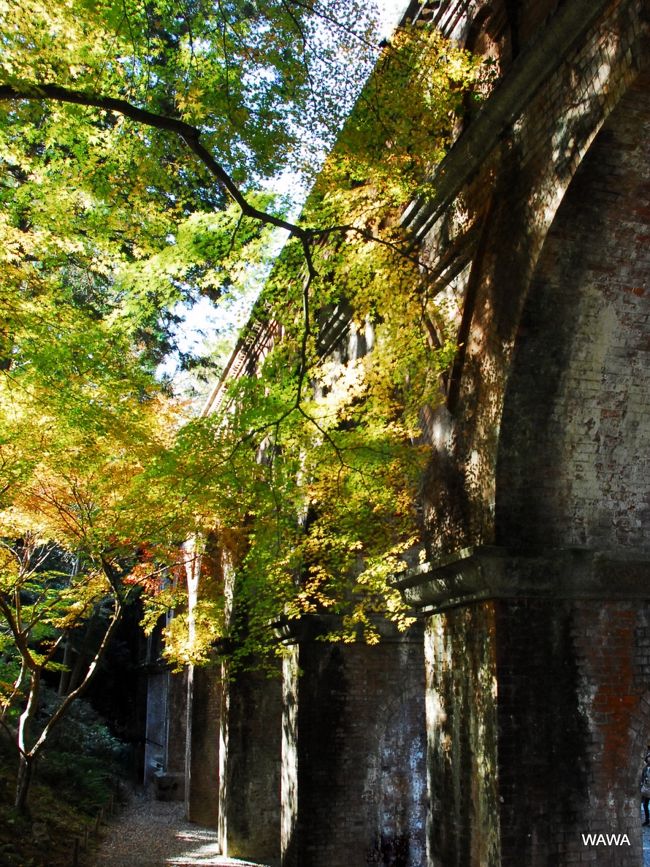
400,547,650,867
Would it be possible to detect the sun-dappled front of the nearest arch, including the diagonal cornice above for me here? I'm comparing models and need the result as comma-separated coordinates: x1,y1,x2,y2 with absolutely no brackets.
412,0,647,559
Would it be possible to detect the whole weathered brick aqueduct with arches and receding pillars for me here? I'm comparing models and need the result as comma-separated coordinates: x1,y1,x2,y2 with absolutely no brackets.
142,0,650,867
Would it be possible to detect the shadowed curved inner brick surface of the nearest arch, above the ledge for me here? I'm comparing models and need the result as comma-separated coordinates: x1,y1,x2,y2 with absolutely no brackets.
495,74,650,552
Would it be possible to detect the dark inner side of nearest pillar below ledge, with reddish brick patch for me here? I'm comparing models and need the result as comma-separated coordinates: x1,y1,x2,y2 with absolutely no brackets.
497,600,650,867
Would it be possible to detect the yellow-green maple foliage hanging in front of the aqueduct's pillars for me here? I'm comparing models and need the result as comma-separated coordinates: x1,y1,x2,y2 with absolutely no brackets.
125,22,478,662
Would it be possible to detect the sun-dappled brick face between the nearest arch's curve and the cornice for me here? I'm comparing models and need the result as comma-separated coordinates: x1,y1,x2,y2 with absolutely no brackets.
412,0,647,553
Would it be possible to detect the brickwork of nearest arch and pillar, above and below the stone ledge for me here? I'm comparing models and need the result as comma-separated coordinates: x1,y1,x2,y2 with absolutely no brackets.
410,0,650,867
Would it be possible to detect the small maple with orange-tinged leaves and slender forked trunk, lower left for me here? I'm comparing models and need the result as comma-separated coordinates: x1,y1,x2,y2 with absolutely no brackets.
0,298,186,809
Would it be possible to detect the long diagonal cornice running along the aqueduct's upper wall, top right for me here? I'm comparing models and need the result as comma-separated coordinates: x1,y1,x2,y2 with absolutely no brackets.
401,0,611,240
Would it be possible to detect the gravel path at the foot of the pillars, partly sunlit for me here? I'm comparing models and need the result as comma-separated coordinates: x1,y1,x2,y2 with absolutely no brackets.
92,795,263,867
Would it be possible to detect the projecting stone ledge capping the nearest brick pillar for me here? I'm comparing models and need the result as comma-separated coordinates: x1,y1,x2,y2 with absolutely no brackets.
393,545,650,613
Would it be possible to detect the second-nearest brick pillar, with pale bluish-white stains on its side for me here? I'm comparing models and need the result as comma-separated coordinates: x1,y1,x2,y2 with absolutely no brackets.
283,633,426,867
